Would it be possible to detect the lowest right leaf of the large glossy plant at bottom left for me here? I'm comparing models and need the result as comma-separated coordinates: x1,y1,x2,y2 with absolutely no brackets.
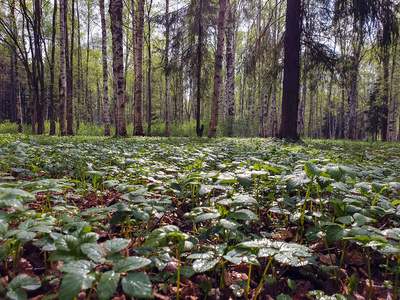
122,272,154,299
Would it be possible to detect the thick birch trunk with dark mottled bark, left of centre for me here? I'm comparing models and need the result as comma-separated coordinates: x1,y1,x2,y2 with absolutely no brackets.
109,0,127,137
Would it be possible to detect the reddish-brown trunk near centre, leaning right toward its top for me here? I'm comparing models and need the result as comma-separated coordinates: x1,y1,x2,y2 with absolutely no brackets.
208,0,226,138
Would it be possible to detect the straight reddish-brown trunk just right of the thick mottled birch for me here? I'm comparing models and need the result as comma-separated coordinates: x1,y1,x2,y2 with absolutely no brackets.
133,0,144,135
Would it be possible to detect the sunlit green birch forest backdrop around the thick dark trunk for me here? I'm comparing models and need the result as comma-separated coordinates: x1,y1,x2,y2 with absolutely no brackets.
0,0,400,141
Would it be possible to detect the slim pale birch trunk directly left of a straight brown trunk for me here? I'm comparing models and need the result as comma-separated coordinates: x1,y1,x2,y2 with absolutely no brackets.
59,0,67,136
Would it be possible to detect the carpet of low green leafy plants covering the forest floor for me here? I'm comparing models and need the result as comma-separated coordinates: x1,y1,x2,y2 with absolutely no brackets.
0,135,400,300
